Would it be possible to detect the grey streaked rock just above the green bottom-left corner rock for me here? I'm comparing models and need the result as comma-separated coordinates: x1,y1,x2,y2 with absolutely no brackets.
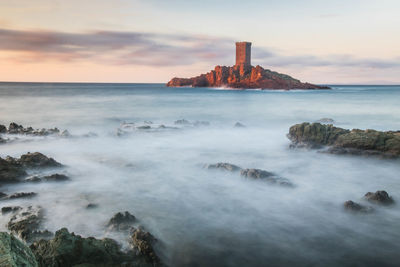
7,206,52,242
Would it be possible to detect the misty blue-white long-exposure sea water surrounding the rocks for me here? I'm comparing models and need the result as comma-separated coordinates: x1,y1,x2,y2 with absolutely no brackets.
0,83,400,266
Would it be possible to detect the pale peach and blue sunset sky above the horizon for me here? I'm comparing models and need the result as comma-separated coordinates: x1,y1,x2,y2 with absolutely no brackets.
0,0,400,84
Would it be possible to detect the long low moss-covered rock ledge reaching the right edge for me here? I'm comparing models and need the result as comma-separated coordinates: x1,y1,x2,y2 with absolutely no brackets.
288,122,400,158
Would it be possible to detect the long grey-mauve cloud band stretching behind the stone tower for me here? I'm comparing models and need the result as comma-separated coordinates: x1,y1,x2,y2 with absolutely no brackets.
0,26,400,68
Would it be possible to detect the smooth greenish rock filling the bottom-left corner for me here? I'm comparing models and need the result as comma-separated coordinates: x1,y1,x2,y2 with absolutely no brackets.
0,232,38,267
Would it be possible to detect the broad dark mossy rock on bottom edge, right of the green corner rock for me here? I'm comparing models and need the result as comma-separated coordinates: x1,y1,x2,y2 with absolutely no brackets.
30,228,153,267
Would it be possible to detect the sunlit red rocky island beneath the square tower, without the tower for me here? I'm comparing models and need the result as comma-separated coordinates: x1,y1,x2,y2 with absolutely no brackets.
167,64,329,90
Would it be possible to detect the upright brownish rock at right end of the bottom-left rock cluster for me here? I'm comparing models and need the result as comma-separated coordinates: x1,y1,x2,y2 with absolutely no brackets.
129,228,160,265
